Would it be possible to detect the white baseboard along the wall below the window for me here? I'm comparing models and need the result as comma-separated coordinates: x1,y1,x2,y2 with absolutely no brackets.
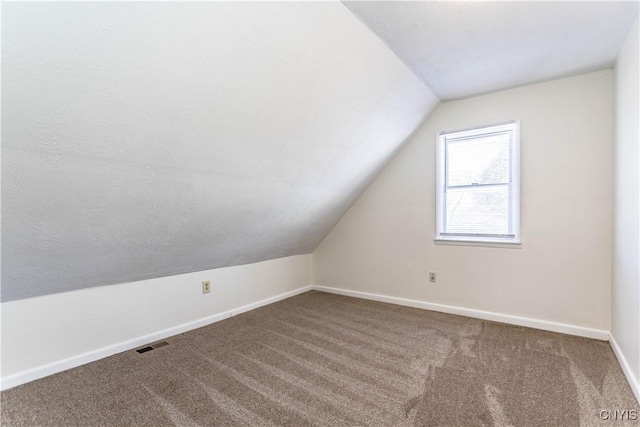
312,285,609,341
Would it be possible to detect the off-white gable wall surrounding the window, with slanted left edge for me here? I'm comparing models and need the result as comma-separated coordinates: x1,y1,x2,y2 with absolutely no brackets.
313,70,612,339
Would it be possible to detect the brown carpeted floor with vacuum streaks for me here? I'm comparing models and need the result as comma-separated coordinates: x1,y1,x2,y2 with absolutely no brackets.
1,292,640,427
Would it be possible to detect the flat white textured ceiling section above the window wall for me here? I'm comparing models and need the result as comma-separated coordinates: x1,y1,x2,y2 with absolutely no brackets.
345,1,638,100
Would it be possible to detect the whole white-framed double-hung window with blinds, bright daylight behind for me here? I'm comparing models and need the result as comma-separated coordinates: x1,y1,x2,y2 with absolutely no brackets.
436,121,520,243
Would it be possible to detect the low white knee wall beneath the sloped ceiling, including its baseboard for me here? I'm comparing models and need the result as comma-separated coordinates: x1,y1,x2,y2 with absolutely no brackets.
0,255,311,388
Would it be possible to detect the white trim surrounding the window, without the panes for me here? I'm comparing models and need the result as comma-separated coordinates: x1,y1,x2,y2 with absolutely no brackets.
434,120,522,247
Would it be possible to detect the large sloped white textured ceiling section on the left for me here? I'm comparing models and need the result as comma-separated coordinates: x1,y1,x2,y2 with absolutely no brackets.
2,2,438,301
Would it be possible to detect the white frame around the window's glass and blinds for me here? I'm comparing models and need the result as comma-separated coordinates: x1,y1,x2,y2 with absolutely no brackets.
435,120,521,246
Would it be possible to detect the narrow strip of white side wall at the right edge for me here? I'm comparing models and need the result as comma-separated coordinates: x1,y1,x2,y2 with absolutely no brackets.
611,15,640,400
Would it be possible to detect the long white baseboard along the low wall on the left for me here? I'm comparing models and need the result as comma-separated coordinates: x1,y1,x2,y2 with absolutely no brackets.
0,286,311,390
